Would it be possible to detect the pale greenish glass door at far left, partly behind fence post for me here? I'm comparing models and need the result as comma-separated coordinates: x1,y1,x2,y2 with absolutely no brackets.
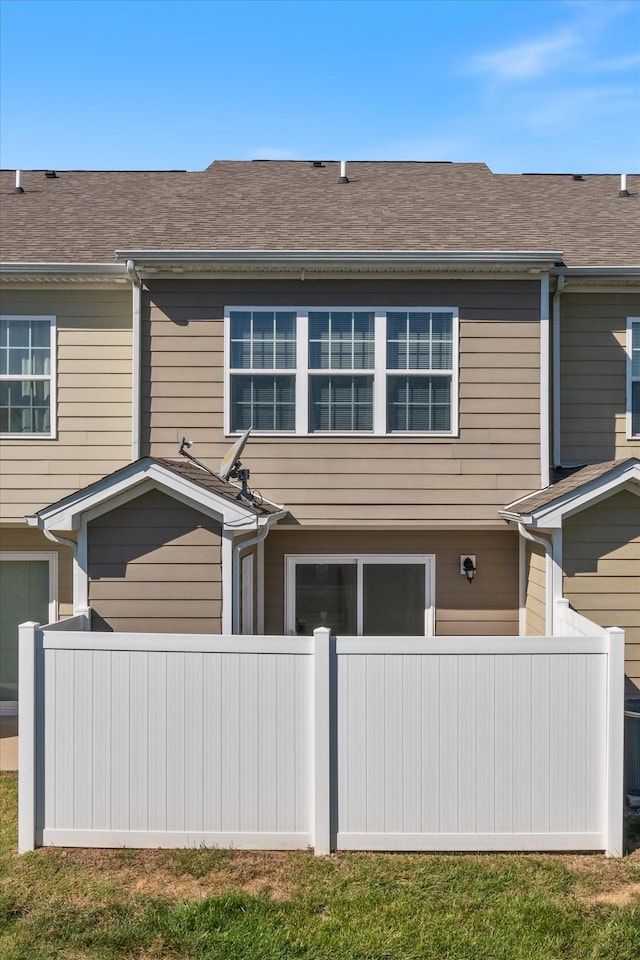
0,560,49,704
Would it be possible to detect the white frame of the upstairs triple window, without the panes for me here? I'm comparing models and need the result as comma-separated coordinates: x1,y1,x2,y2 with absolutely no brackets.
224,304,460,439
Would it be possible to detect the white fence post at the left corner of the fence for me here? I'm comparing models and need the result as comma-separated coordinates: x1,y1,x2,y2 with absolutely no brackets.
18,621,40,853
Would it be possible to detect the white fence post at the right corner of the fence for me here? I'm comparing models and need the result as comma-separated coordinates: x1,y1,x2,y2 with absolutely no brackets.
606,627,624,857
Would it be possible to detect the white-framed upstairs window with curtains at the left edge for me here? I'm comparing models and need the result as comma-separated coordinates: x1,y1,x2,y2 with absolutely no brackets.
0,316,55,437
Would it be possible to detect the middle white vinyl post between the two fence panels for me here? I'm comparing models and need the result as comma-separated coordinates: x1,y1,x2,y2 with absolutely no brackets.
313,627,331,856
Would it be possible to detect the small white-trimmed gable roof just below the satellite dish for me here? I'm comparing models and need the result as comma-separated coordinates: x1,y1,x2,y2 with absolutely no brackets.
26,457,286,531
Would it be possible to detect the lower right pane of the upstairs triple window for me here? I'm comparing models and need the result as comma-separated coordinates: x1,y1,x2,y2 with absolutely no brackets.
387,377,451,433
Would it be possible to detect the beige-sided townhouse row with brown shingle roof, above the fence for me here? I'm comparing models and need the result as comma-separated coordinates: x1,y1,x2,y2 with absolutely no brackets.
0,161,640,710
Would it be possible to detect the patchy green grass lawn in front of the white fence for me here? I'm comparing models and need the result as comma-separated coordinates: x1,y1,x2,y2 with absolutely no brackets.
0,775,640,960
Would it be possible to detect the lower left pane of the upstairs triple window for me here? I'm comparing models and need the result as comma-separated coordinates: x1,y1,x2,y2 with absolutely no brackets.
231,376,295,432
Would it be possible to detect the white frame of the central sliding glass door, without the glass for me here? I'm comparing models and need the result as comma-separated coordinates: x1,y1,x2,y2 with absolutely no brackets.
284,553,436,637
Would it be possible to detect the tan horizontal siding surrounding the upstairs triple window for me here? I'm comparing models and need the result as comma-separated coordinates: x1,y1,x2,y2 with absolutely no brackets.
142,280,540,529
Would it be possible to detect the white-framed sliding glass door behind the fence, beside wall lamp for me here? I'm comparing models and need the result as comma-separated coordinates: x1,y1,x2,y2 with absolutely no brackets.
285,554,434,637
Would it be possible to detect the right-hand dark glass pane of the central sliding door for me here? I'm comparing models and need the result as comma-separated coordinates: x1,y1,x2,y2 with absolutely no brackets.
362,563,425,637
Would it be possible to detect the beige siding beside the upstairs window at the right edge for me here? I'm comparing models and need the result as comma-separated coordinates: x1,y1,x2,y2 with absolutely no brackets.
560,293,640,463
